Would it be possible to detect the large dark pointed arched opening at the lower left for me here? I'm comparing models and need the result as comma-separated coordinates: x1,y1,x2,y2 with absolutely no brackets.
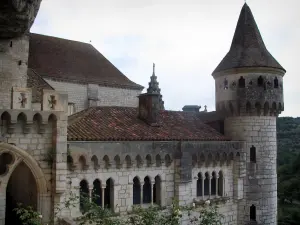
5,162,38,225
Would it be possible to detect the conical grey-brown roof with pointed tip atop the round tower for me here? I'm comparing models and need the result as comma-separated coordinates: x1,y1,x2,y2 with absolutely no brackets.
213,3,285,74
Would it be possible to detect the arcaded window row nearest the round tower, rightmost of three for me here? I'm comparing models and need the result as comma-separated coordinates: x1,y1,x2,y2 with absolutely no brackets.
197,171,224,197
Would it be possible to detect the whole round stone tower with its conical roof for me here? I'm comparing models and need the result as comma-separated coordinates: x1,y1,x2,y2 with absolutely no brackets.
212,4,286,225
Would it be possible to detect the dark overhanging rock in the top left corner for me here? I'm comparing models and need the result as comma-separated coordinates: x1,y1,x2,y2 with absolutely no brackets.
0,0,42,38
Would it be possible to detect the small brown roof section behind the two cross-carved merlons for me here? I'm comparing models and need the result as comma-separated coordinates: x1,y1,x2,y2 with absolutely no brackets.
27,68,53,102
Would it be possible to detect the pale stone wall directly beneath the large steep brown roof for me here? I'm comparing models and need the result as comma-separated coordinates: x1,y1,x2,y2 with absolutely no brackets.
45,79,141,112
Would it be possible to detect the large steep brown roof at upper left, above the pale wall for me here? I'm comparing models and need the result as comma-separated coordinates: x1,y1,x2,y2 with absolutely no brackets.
28,33,143,90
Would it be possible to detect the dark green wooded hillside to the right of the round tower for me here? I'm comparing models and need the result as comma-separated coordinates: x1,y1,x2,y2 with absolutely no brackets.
277,117,300,225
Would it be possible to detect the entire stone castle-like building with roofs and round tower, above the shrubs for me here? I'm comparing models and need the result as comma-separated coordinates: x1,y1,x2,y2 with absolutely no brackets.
0,0,286,225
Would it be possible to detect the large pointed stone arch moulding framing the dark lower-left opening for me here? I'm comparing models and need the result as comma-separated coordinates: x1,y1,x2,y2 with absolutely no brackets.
0,143,51,224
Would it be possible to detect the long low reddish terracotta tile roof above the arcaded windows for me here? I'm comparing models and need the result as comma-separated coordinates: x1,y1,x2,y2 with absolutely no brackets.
68,107,229,141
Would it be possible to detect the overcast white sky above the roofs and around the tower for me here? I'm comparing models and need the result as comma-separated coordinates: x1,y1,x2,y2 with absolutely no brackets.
31,0,300,116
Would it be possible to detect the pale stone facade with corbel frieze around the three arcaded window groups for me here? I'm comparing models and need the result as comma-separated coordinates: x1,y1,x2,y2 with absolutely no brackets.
67,142,244,225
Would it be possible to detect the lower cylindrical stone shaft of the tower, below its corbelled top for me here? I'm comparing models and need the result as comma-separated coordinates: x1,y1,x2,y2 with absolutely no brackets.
225,116,277,225
